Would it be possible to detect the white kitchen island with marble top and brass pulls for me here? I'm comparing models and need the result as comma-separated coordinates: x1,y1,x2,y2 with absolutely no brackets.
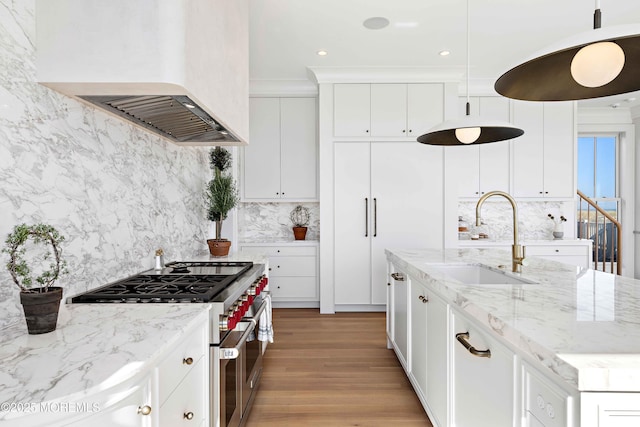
387,249,640,427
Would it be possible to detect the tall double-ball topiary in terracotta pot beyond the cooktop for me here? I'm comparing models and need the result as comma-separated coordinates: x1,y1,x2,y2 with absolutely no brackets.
206,147,239,257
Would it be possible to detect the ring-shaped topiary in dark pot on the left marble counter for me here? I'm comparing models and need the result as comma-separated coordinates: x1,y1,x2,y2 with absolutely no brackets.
2,224,67,335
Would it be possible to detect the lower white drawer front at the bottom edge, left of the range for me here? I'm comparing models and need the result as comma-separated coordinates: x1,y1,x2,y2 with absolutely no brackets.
159,358,208,427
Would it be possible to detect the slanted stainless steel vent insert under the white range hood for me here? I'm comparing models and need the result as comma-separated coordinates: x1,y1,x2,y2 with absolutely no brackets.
80,95,239,143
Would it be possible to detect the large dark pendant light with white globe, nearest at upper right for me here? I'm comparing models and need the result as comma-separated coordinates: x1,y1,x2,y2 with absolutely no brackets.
495,0,640,101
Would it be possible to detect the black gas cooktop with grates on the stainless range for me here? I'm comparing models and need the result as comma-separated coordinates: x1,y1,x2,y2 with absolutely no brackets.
71,261,253,303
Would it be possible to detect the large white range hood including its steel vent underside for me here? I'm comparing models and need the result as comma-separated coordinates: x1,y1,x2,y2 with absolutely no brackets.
36,0,249,146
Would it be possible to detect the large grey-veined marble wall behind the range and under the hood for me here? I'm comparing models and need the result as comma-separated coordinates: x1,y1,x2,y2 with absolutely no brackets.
0,0,211,329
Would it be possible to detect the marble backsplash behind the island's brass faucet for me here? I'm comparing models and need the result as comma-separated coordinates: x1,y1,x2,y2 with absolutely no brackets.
458,197,576,241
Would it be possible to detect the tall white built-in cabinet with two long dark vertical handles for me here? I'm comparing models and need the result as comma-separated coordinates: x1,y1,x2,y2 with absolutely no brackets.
316,74,450,313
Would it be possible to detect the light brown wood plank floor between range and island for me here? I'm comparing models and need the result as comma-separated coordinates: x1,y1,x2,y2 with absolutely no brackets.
246,309,431,427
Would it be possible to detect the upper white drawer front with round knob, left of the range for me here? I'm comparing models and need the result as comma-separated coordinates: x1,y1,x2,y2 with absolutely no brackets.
158,327,207,404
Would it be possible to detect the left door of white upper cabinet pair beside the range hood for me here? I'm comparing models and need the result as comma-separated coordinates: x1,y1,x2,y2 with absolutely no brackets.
243,98,280,199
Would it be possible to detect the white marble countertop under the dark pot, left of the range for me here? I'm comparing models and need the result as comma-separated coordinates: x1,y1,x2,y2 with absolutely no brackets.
0,304,209,425
